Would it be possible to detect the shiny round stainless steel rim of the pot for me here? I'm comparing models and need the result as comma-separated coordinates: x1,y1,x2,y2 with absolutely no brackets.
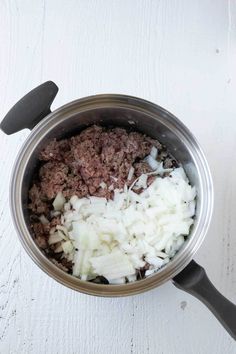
10,94,214,297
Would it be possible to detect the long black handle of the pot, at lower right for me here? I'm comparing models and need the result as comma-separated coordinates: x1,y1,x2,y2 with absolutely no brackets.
173,261,236,340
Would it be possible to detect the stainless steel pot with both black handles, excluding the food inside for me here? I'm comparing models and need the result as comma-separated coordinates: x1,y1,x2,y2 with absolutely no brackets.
1,81,236,338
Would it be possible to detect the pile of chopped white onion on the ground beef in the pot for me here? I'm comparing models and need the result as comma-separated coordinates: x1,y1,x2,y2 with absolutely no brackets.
49,167,196,284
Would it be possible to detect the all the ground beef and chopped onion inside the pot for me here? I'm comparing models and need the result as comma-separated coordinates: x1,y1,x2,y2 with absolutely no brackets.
29,125,196,284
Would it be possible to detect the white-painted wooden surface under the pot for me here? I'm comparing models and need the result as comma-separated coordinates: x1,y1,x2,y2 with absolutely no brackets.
0,0,236,354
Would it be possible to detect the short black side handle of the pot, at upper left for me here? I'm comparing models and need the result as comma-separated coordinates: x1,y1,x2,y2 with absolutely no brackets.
0,81,58,135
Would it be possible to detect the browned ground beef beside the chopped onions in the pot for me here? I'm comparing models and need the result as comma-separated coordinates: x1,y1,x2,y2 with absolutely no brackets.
29,125,177,271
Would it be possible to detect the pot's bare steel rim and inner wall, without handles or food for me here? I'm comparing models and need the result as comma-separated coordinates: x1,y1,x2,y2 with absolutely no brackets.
10,95,213,296
